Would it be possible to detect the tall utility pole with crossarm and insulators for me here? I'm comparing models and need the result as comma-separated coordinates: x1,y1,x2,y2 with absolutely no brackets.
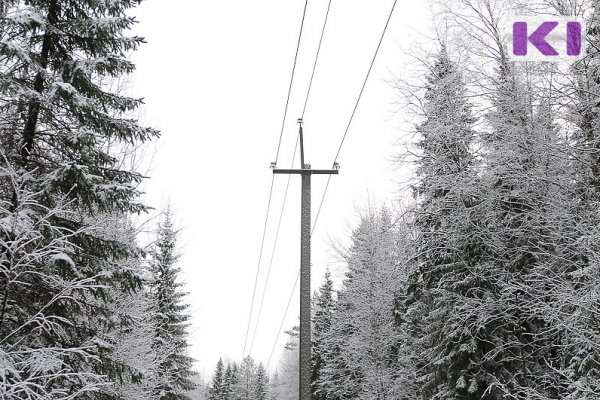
273,118,339,400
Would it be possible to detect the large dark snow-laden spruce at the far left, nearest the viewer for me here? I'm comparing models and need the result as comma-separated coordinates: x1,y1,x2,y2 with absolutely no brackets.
0,0,158,399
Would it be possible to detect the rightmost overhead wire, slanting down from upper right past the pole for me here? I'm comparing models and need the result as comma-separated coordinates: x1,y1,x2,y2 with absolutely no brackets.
266,0,398,368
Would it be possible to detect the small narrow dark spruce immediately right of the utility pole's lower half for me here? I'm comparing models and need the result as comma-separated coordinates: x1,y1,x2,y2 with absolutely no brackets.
311,270,335,400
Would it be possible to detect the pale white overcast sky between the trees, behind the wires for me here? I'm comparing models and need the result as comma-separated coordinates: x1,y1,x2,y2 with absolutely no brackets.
131,0,431,378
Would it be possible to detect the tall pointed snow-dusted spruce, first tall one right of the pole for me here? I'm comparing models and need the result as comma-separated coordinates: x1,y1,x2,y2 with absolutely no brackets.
400,47,481,398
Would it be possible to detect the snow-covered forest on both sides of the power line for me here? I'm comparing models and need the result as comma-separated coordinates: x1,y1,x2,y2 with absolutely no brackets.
0,0,600,400
